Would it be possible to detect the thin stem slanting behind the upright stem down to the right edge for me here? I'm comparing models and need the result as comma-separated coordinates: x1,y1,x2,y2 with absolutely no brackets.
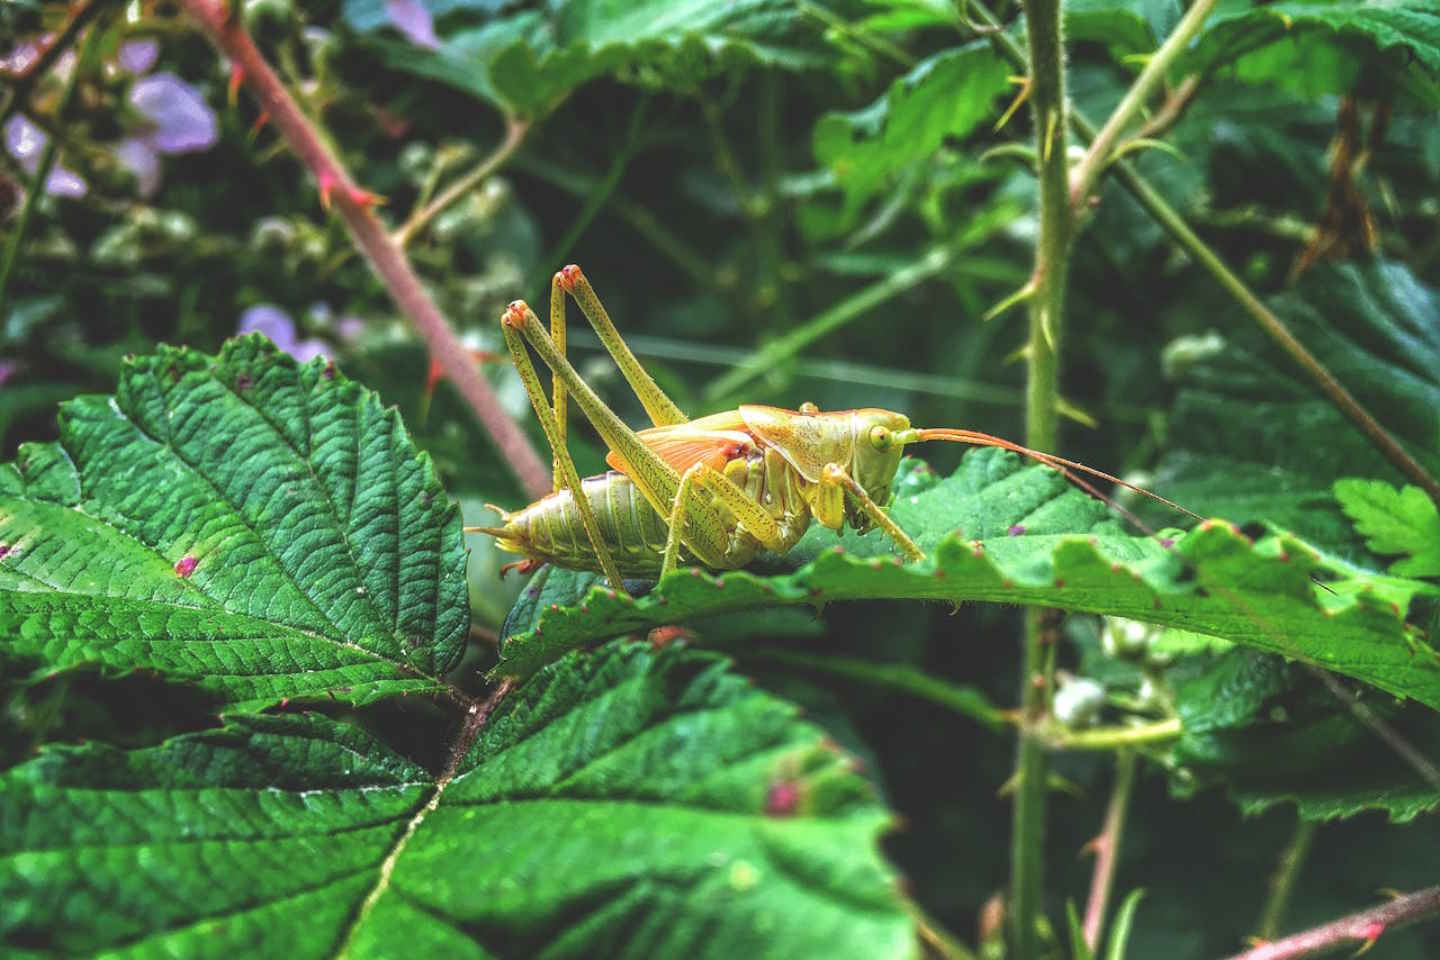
969,0,1440,505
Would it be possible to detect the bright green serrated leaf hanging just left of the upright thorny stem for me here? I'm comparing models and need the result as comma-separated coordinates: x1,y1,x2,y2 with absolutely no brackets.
814,43,1009,206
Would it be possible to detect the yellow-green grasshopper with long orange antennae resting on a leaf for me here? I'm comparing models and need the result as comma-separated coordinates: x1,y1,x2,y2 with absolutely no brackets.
467,265,1195,590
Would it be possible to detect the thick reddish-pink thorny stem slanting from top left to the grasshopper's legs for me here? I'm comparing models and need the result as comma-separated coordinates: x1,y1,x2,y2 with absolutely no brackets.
180,0,552,497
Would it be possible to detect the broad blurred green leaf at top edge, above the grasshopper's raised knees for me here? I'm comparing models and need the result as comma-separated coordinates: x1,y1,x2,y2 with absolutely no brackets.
352,0,832,117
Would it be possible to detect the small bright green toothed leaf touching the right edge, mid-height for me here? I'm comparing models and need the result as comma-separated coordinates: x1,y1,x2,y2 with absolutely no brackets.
1335,478,1440,577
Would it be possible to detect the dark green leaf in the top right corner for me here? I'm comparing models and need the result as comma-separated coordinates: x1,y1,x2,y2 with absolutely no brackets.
1179,0,1440,107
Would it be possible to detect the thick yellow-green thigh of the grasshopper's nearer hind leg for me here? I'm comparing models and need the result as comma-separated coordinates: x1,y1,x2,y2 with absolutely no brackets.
501,299,726,563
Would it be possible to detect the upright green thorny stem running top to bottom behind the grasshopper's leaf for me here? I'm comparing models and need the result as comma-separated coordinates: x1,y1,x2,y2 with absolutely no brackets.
1009,0,1071,960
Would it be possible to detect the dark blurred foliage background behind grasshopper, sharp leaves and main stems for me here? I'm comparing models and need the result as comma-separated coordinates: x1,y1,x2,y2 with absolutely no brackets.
0,0,1440,957
